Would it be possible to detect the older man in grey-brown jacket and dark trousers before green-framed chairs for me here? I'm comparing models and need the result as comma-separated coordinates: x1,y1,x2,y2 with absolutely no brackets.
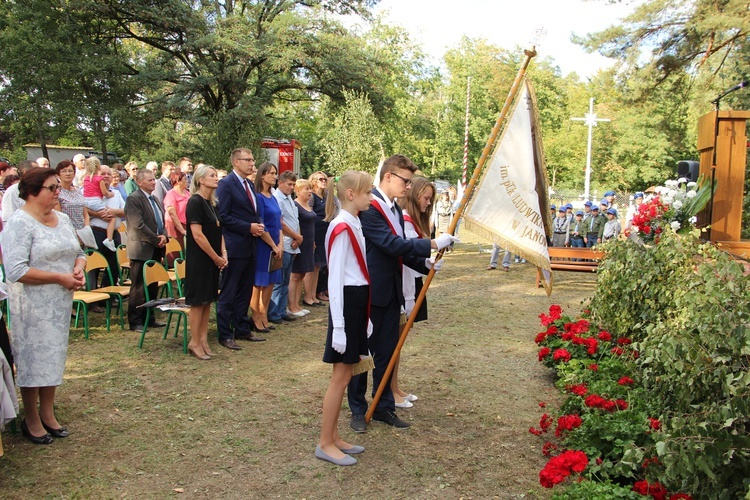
125,169,167,330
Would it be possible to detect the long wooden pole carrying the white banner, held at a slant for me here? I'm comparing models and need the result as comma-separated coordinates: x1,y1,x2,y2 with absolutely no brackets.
365,47,536,422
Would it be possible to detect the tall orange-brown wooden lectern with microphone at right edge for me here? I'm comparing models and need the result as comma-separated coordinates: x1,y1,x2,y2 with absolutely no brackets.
698,110,750,252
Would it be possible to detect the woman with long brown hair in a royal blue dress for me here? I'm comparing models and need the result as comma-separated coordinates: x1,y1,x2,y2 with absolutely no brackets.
250,162,284,333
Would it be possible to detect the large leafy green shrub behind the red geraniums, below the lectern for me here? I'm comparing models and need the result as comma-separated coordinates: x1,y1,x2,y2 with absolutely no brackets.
589,232,750,498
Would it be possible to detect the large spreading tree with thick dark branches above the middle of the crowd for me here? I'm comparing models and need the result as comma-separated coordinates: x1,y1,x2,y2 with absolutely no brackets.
91,0,390,161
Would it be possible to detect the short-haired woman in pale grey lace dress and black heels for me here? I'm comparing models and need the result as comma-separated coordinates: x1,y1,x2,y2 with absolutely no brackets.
2,168,86,444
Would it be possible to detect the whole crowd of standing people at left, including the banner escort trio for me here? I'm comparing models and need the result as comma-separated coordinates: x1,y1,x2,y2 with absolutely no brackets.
0,148,458,465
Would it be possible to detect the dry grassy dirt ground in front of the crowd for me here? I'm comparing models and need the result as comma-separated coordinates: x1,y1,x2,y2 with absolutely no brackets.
0,231,595,499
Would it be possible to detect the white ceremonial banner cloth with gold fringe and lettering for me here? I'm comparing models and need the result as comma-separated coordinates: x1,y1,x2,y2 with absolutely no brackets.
464,81,552,293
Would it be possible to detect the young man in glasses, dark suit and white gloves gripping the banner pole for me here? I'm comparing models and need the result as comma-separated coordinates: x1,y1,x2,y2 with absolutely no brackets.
347,155,457,432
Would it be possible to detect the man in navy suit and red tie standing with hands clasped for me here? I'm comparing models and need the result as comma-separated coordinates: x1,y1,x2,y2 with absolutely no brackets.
216,148,266,350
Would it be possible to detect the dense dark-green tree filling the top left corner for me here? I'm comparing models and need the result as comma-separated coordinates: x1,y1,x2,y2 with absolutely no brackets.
0,0,141,156
